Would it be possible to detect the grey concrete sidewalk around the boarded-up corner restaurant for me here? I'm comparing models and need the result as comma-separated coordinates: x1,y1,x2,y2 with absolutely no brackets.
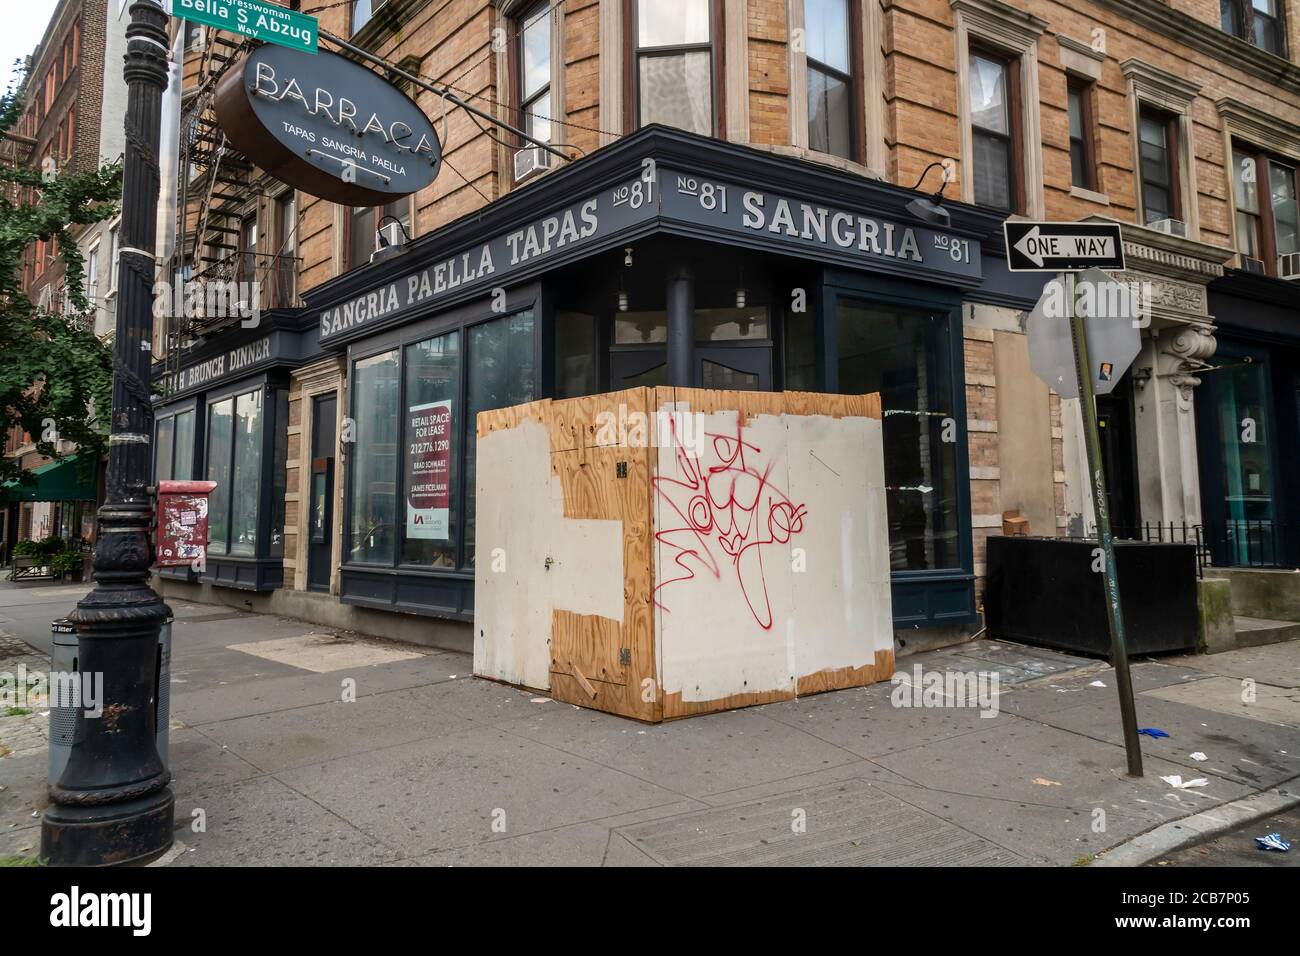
0,585,1300,865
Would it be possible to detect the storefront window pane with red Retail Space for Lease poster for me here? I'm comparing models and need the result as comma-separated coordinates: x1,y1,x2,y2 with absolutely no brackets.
402,332,460,570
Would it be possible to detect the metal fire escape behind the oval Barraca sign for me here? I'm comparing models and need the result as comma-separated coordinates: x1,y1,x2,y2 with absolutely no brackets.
165,29,300,390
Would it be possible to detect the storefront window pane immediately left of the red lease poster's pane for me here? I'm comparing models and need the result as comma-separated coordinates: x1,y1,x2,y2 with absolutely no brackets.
348,349,398,564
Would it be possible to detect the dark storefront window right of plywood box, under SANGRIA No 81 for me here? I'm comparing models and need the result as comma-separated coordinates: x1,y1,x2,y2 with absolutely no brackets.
837,299,961,571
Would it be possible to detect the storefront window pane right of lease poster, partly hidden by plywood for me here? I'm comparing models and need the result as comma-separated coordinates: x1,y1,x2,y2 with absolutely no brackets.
464,311,536,567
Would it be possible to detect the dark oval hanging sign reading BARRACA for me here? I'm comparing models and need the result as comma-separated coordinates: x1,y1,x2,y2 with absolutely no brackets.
216,44,442,206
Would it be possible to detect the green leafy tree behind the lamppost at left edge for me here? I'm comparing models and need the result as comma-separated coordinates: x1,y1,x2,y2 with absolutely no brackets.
0,68,122,502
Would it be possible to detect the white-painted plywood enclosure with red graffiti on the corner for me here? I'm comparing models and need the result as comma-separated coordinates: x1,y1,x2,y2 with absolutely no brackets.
475,388,893,722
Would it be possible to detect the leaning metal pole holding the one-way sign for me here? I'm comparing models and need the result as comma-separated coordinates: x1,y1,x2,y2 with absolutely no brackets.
1066,272,1143,777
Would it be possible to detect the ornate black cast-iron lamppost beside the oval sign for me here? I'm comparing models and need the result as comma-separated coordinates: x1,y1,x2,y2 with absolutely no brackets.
40,0,174,866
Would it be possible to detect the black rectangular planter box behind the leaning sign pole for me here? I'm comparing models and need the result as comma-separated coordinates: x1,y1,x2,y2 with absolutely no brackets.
984,535,1197,658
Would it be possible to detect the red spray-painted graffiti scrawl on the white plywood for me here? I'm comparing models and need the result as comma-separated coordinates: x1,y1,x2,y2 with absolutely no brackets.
654,412,807,631
